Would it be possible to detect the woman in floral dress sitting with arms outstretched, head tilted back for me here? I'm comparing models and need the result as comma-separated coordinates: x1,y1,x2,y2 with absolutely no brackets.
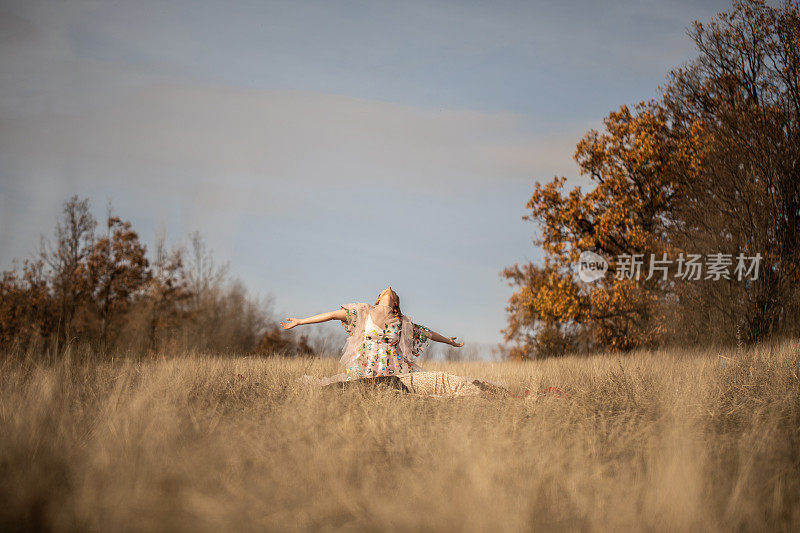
281,286,507,396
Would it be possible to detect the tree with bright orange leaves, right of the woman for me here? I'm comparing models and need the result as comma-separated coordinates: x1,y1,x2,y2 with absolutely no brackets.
503,102,700,358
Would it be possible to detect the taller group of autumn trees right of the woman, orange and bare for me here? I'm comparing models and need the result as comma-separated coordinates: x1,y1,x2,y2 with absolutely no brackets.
502,0,800,358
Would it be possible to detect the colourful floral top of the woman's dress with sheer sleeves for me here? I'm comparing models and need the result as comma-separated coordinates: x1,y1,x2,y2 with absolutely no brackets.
341,304,431,380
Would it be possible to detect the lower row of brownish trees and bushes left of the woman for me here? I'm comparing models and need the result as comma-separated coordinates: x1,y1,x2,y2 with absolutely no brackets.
0,196,319,355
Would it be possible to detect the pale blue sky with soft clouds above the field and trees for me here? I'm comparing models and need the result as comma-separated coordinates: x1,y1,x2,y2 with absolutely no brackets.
0,0,730,350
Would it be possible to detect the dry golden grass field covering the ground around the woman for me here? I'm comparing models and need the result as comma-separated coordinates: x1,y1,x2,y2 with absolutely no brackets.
0,341,800,531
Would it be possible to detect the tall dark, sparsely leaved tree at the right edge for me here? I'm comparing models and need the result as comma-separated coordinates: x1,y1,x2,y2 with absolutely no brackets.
664,0,800,341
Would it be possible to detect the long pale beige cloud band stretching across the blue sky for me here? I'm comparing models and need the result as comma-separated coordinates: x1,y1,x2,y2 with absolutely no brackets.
0,81,588,185
